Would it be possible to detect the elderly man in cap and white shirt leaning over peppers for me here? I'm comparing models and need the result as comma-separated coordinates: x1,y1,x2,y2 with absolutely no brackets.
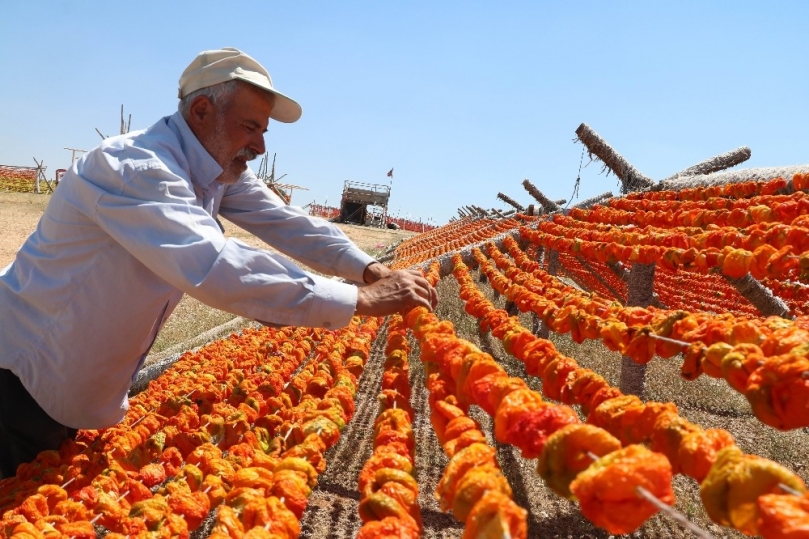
0,48,437,477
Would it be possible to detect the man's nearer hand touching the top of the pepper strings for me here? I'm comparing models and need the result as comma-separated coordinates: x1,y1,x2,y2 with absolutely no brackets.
356,264,438,316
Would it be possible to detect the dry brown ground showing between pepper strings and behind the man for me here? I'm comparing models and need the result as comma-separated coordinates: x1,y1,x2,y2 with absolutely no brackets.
0,193,809,539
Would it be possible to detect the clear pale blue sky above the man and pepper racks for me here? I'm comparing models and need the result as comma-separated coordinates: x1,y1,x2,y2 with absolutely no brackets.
0,0,809,224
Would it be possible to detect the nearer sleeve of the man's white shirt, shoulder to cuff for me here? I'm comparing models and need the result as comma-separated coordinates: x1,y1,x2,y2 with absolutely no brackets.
85,148,357,328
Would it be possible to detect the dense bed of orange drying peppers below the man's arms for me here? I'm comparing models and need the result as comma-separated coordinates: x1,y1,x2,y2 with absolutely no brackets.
0,319,378,538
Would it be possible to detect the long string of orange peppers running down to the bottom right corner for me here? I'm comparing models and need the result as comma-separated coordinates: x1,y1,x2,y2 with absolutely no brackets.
453,255,809,539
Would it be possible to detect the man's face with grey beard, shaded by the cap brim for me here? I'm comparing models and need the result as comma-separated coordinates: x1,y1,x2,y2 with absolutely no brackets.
199,84,272,184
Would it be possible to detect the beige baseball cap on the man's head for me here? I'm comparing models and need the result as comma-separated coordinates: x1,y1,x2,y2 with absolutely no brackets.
179,47,302,123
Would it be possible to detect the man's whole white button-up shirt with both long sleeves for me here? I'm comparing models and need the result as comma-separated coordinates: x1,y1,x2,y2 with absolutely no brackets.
0,113,373,429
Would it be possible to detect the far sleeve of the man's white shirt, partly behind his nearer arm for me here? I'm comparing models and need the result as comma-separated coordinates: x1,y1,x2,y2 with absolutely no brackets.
219,171,375,283
